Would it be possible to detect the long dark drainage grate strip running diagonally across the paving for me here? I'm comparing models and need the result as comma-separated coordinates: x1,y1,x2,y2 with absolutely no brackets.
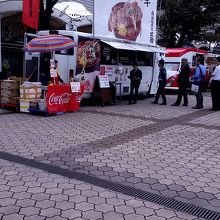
0,152,220,220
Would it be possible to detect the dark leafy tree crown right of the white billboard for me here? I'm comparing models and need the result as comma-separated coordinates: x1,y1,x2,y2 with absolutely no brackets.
159,0,220,47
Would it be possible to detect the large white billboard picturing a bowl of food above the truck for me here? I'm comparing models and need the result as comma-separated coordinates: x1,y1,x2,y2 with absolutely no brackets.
94,0,157,46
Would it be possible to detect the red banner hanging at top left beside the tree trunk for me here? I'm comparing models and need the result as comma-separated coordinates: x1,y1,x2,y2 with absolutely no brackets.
22,0,40,29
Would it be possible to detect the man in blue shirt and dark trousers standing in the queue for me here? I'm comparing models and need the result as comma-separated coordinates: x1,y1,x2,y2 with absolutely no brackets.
192,58,206,109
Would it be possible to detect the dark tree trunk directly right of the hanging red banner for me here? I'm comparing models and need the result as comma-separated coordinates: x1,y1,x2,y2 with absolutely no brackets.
39,0,58,30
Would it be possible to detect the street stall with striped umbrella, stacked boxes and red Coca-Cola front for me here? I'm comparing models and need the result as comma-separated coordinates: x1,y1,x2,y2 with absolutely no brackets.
1,35,86,115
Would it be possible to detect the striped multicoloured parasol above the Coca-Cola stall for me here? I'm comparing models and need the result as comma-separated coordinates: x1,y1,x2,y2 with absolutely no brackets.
23,35,76,53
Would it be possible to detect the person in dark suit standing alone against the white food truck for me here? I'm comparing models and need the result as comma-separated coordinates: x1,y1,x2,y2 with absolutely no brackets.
128,63,142,105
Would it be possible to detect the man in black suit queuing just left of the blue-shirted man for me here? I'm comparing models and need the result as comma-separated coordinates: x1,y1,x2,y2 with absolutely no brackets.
171,58,191,106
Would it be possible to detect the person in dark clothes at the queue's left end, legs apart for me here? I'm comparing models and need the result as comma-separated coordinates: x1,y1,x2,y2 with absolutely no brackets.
151,60,167,105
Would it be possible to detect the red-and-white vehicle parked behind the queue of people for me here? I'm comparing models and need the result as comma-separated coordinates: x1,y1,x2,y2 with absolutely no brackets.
163,48,207,90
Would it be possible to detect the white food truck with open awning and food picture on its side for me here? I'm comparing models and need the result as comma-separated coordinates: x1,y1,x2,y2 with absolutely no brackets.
25,30,164,97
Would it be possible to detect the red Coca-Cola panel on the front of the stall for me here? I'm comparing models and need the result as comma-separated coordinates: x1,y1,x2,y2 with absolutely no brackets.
46,84,84,114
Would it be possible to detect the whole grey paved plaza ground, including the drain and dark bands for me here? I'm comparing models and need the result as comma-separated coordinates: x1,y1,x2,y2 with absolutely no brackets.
0,94,220,220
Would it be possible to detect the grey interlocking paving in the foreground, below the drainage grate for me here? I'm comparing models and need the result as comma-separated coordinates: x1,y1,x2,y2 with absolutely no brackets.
0,160,202,220
